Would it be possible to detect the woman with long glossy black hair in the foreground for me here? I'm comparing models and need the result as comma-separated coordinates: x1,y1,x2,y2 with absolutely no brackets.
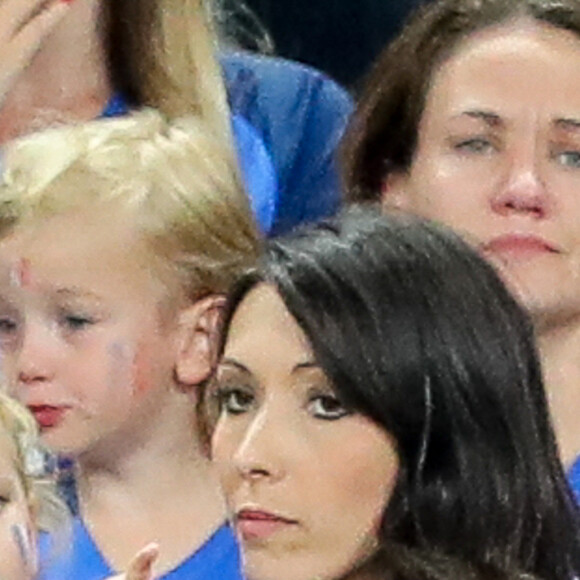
206,211,580,580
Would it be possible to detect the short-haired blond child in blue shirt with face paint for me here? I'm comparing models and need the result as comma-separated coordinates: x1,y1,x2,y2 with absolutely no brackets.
0,111,259,580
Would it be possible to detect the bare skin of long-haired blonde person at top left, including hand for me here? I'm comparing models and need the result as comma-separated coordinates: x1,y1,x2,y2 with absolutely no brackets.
0,0,112,144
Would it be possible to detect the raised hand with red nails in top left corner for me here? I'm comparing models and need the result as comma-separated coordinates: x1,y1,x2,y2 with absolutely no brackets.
0,0,74,107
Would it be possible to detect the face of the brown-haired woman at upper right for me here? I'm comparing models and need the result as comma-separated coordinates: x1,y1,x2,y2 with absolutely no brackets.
383,20,580,320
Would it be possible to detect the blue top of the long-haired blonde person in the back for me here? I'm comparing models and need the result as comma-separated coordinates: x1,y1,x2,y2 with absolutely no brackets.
103,52,352,234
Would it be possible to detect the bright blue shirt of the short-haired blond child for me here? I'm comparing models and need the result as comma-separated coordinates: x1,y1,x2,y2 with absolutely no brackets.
38,518,242,580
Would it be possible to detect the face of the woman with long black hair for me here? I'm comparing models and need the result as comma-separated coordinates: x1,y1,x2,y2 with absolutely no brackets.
211,284,398,580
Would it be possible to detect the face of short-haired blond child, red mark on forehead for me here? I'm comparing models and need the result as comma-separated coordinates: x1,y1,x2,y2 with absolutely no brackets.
0,208,181,456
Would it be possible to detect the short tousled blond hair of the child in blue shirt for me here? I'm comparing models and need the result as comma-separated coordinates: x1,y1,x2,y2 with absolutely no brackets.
0,110,260,300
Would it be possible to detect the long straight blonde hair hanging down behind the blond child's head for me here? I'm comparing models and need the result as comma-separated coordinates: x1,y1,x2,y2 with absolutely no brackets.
104,0,234,147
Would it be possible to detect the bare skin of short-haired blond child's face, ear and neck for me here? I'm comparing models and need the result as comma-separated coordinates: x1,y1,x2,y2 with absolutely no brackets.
0,208,225,578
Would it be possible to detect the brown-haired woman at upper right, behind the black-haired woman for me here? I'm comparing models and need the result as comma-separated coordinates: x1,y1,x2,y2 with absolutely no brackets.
345,0,580,497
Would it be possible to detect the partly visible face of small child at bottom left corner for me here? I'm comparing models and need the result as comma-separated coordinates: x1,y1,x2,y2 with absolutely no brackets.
0,426,36,580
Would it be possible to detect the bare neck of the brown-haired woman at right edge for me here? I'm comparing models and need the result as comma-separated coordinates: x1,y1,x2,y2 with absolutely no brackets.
538,324,580,467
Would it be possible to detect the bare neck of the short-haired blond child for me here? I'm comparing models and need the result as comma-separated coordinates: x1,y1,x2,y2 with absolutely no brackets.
73,392,225,573
